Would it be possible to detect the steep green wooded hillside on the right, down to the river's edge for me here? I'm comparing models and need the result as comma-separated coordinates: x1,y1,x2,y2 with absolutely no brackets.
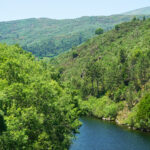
52,18,150,130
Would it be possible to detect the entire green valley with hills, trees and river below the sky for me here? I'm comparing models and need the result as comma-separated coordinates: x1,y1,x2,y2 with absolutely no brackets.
0,7,150,150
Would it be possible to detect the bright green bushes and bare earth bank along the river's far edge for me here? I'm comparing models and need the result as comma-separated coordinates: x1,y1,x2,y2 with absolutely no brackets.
79,95,150,132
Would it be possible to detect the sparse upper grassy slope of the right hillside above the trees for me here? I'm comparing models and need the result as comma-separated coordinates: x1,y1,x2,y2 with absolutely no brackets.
52,19,150,83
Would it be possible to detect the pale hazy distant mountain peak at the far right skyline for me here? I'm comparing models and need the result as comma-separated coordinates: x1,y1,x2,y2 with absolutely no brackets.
124,7,150,15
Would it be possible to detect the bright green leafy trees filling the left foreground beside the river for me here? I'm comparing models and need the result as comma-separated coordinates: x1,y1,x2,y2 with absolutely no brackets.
0,44,79,150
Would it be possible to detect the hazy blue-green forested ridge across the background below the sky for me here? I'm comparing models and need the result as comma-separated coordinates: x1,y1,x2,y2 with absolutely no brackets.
0,15,144,57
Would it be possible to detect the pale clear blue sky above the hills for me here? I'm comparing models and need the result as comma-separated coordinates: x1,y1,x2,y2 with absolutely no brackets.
0,0,150,21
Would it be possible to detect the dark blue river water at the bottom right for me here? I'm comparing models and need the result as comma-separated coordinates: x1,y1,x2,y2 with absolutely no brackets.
70,118,150,150
